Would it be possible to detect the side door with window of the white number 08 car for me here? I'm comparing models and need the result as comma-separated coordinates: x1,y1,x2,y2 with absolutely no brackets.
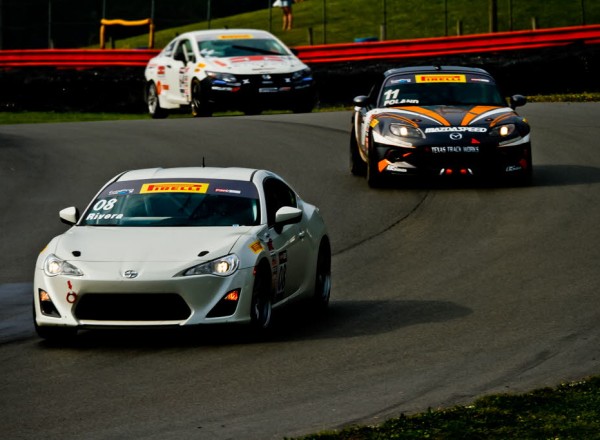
263,177,310,301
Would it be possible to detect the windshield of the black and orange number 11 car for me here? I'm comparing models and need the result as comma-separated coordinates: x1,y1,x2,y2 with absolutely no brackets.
378,74,506,107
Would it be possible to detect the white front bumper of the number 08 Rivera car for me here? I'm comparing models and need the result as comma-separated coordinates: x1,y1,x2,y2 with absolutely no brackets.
33,268,254,328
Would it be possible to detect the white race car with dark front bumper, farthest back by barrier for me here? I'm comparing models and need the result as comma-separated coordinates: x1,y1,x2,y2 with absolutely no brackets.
145,29,316,118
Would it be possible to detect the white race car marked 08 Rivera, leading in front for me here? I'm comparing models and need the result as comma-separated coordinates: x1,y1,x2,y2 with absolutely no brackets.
33,167,331,339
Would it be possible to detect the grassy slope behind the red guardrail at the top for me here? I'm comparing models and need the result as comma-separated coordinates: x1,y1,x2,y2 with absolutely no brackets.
105,0,600,48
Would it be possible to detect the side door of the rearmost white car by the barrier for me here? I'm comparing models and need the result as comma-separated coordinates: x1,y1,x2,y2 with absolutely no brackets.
163,38,196,104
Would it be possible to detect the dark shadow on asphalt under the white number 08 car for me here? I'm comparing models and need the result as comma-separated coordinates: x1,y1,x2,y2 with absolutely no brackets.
39,300,472,350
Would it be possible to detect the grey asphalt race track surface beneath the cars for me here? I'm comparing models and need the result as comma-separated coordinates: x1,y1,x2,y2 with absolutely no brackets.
0,103,600,439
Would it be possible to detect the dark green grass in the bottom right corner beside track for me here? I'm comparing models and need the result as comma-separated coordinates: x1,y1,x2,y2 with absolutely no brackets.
290,377,600,440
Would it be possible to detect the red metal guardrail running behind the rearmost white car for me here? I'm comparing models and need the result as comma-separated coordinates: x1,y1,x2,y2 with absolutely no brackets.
0,25,600,69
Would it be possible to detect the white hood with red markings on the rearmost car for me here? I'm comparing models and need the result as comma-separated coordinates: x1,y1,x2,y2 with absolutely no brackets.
204,55,306,75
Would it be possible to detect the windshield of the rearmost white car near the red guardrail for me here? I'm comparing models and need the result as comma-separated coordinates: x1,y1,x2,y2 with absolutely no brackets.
198,38,289,58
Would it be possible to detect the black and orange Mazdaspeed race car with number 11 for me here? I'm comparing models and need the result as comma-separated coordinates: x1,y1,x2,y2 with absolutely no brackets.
350,66,533,187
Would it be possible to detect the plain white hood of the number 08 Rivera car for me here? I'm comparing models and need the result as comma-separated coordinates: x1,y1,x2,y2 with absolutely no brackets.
55,226,250,262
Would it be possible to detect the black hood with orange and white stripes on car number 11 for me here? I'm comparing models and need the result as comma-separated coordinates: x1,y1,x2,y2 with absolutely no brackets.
373,105,517,127
